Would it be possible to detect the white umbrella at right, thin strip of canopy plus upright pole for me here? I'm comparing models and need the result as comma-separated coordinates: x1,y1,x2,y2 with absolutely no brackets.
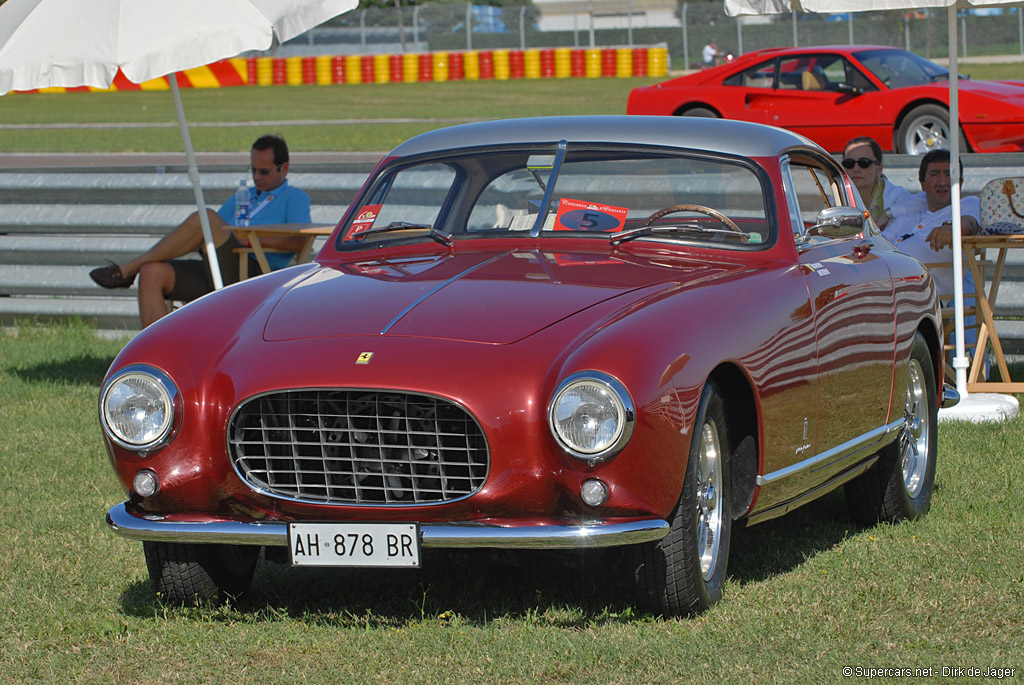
725,0,1024,413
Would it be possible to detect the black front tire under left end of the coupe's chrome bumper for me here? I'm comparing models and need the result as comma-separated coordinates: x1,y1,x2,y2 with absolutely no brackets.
142,541,260,604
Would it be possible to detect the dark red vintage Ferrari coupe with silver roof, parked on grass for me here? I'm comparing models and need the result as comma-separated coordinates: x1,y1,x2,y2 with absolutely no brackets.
99,116,955,614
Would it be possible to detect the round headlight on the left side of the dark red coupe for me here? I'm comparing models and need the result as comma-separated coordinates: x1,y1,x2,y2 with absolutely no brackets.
100,369,177,451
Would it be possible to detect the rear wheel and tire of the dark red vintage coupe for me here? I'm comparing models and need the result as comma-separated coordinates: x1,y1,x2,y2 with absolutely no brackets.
846,333,938,525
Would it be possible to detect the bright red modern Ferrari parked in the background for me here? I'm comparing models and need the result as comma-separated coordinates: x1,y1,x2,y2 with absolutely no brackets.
627,45,1024,155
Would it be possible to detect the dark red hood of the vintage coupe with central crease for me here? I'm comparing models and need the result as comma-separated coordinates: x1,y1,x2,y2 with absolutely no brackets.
263,246,720,344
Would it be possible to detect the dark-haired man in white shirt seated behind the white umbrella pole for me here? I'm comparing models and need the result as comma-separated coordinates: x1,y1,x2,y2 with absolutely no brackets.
882,149,980,298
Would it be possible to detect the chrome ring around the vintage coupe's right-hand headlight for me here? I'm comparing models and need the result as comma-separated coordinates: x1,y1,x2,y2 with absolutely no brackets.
548,371,636,464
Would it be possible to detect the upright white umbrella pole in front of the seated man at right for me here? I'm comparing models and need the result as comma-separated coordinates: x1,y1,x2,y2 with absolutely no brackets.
948,4,968,397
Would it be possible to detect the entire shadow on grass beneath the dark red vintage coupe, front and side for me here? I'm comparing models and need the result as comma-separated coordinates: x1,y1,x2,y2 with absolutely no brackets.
122,483,888,628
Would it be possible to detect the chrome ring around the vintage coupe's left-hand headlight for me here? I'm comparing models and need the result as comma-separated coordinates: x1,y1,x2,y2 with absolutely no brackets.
99,365,182,456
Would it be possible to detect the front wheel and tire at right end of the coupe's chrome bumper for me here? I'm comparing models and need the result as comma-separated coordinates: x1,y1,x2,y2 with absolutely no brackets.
629,381,732,616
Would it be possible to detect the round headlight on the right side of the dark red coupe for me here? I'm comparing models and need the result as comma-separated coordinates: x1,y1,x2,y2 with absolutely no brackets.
549,372,634,461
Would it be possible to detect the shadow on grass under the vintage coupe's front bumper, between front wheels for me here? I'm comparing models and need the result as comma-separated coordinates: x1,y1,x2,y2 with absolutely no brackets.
121,550,637,628
